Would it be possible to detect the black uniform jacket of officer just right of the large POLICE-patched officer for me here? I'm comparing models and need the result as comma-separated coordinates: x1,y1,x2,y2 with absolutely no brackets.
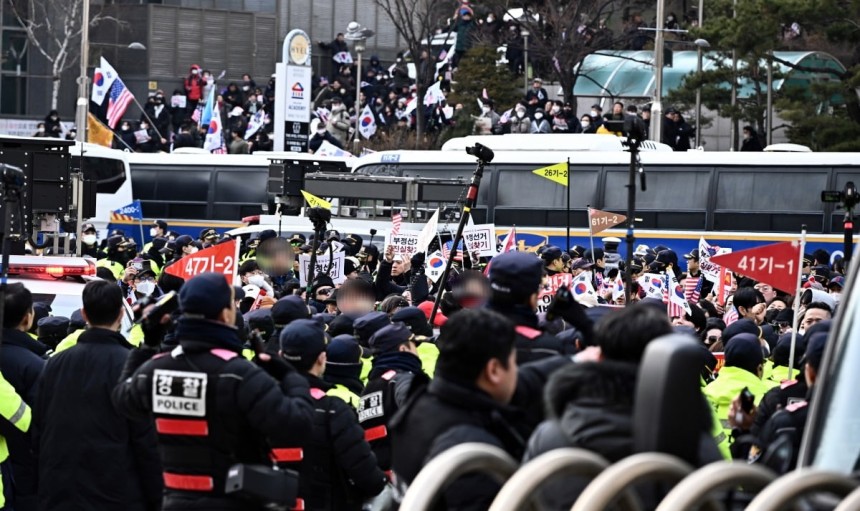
272,374,387,511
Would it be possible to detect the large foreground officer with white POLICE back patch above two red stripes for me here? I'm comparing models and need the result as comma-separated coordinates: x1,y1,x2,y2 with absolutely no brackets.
113,273,313,511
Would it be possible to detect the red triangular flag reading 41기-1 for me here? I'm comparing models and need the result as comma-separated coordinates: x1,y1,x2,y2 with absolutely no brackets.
711,241,800,294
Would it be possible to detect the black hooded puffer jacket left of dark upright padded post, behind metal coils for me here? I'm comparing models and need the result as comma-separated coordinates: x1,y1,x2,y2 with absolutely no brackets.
524,360,637,510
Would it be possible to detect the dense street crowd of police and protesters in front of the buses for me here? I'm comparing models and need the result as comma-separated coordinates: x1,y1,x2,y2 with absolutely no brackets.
0,214,844,510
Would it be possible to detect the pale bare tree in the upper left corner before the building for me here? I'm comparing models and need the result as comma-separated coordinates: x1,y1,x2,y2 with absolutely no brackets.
4,0,117,110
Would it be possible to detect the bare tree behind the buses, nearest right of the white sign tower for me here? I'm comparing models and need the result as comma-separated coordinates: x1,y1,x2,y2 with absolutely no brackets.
374,0,453,145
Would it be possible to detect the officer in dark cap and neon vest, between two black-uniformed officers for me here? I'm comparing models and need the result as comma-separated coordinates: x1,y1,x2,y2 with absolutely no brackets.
323,334,364,410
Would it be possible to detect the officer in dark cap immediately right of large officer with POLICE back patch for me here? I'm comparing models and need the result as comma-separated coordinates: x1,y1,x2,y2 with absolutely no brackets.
275,319,387,511
